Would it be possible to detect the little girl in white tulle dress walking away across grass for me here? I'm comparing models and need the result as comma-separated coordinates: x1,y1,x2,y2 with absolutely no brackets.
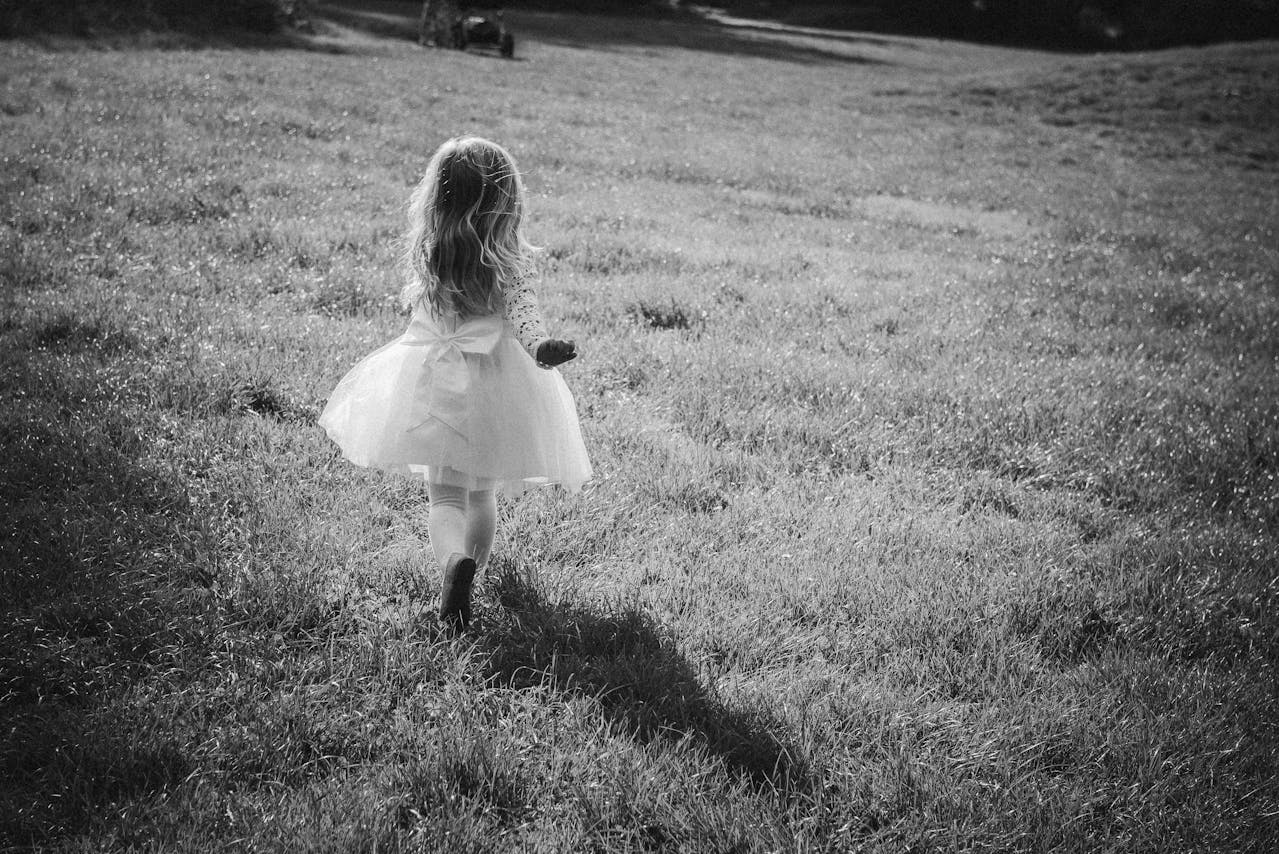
320,137,591,629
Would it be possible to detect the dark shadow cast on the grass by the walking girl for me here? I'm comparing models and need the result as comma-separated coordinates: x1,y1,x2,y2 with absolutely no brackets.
481,566,810,791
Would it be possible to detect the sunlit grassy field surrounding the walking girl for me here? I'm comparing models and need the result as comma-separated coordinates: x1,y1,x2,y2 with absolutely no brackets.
0,4,1279,851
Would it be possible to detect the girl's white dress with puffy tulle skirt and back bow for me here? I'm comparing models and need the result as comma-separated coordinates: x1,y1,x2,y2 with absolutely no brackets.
320,280,591,493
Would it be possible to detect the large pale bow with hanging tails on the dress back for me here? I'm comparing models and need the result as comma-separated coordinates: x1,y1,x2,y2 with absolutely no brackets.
400,314,503,436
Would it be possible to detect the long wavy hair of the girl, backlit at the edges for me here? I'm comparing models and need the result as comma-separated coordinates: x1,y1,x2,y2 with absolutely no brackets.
403,137,536,317
